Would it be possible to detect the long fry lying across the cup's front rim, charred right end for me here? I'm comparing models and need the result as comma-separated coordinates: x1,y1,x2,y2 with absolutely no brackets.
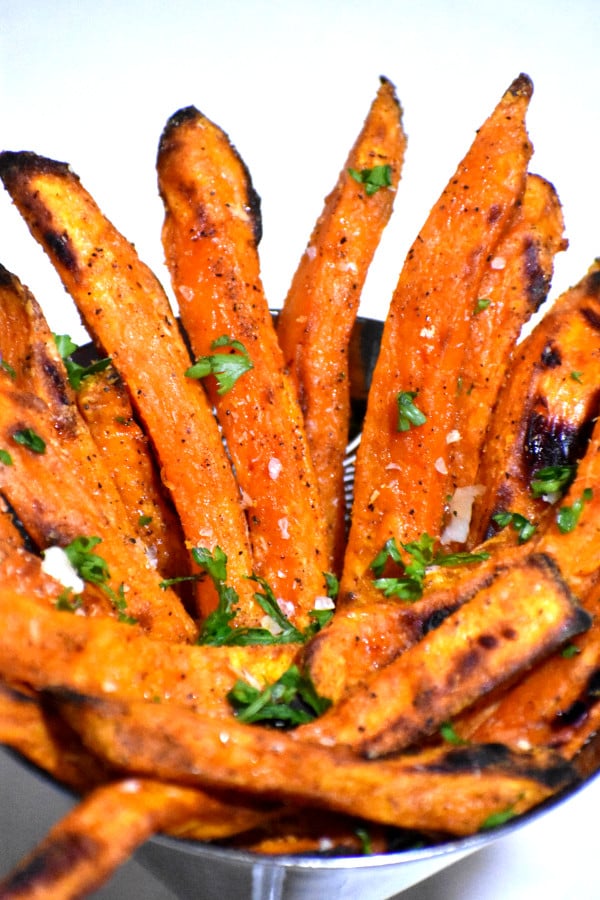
61,697,573,834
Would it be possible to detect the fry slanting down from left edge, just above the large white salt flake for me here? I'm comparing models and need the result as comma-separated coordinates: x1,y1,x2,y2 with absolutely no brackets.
0,373,197,640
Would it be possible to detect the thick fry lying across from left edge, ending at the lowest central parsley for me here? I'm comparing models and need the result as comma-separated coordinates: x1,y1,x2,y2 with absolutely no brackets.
0,579,297,716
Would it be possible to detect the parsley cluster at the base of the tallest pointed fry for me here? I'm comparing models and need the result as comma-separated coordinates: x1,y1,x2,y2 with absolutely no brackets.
371,534,489,601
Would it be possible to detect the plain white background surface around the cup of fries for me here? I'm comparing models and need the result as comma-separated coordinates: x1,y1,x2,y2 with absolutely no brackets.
0,0,600,900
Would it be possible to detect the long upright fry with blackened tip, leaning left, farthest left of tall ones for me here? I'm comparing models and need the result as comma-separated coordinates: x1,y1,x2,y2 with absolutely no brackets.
0,151,256,621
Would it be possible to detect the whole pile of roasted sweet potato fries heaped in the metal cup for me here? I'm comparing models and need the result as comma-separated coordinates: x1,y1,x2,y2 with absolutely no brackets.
0,75,600,898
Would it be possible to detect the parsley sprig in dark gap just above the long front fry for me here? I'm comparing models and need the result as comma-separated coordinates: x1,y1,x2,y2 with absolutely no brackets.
227,665,331,728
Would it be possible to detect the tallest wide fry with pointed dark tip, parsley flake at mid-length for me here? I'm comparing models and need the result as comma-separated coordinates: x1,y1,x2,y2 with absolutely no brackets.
340,76,532,602
